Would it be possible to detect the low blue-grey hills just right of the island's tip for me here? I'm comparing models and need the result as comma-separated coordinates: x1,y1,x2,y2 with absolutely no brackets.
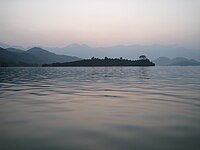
153,57,200,66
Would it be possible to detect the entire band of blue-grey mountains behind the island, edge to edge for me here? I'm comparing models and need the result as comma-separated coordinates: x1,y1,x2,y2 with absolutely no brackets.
0,43,200,66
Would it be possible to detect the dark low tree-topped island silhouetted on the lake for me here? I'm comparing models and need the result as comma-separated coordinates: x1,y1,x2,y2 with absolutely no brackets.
42,55,155,67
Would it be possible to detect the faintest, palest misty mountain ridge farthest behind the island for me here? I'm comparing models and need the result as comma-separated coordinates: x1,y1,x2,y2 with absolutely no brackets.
45,44,200,61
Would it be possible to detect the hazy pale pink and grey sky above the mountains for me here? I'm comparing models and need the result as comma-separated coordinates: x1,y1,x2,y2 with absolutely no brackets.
0,0,200,49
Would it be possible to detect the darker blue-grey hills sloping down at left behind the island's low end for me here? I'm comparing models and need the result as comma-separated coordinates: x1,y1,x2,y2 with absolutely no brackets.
0,47,81,66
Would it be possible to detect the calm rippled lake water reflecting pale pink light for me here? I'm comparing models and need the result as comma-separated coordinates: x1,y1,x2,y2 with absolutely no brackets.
0,67,200,150
